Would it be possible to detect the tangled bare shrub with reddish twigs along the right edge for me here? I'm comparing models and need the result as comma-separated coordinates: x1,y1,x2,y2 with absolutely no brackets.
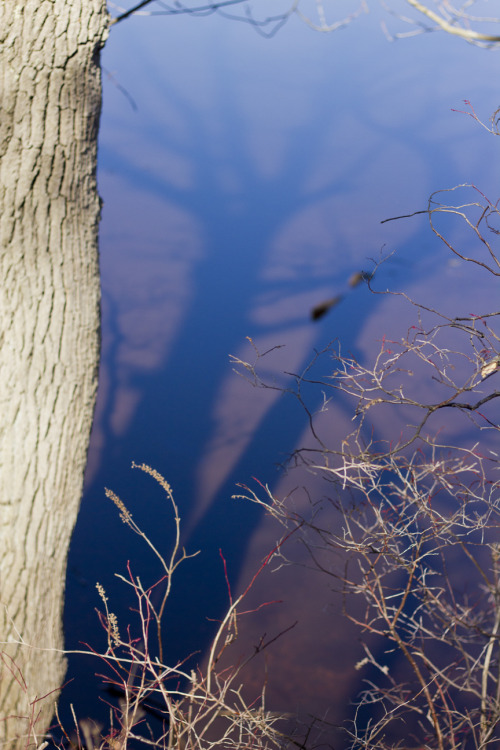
234,109,500,750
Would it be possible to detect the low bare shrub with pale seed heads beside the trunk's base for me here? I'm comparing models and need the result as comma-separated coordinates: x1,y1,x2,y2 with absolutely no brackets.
52,464,304,750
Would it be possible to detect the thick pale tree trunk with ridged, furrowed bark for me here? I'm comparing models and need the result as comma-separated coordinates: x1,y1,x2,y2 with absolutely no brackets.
0,0,109,748
